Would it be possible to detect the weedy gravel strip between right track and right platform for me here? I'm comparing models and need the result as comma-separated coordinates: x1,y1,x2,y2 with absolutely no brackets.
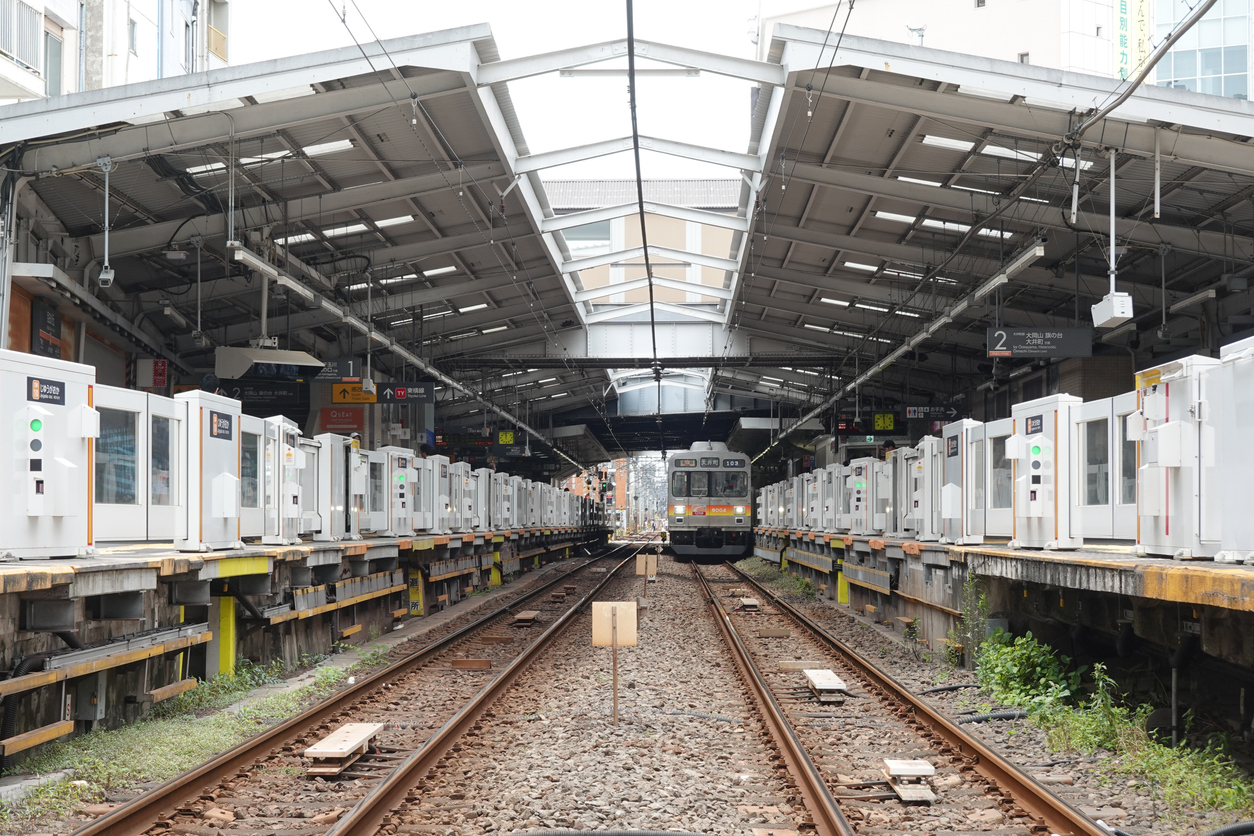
742,569,1236,836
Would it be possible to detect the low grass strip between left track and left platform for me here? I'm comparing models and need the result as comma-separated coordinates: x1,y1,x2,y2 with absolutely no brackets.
0,644,387,835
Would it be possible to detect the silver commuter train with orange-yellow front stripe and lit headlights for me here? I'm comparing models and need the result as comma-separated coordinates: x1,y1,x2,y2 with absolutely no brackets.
666,441,754,559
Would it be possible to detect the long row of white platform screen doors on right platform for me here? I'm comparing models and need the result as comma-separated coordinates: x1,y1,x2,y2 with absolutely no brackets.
755,337,1254,564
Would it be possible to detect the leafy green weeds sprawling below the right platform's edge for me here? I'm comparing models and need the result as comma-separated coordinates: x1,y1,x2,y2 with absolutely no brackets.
977,630,1254,816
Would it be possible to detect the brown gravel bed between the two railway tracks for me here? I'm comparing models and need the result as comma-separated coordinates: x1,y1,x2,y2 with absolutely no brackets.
384,556,805,835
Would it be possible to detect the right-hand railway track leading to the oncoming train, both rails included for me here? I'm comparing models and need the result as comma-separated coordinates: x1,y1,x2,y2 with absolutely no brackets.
693,564,1106,836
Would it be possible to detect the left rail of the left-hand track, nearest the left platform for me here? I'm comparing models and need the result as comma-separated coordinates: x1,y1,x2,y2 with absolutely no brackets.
71,543,636,836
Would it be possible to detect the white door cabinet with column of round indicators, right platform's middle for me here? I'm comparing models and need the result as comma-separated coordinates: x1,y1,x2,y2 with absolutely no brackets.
1006,395,1083,549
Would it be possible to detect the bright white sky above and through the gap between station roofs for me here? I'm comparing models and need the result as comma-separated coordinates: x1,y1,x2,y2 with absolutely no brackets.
229,0,757,179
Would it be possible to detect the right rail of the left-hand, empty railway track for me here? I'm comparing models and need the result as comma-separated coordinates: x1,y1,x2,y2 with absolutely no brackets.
322,541,647,836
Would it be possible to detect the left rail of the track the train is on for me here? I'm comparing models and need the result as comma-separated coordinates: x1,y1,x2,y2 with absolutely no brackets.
692,564,855,836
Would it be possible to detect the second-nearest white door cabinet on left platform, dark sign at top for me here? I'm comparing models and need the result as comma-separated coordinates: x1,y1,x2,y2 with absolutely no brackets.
174,391,243,551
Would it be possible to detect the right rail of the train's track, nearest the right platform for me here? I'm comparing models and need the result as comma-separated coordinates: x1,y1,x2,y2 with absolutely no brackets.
726,563,1110,836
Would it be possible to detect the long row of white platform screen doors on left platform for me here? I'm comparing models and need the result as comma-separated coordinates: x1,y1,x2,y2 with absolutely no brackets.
0,350,612,559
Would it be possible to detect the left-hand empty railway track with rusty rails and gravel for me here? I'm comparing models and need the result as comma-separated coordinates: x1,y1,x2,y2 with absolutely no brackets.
74,540,650,836
